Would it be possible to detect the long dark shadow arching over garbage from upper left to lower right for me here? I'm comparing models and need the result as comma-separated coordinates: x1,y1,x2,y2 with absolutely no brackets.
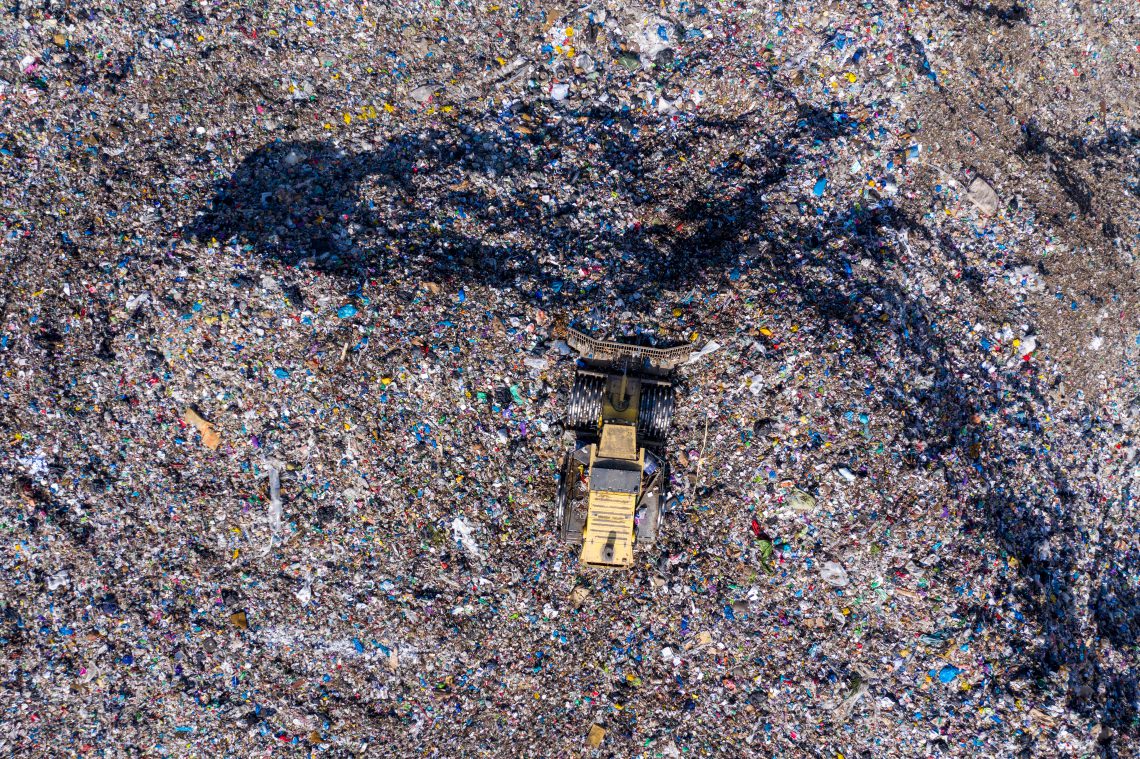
191,105,1140,729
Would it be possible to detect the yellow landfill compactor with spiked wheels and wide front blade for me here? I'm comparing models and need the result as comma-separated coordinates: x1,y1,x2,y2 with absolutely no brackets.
554,329,692,569
